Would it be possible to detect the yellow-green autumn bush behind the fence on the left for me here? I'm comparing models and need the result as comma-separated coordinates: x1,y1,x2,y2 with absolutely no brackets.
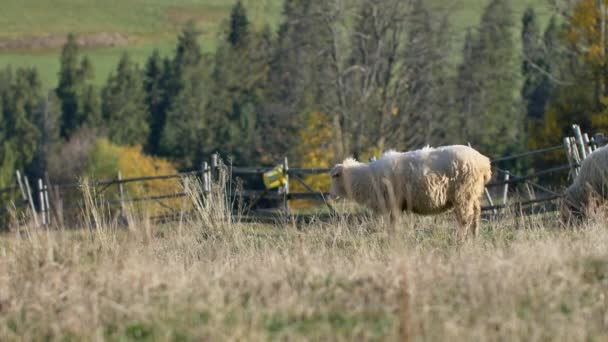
87,138,183,215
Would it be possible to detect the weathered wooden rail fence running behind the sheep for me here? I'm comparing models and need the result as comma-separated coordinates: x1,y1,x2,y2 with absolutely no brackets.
0,125,603,224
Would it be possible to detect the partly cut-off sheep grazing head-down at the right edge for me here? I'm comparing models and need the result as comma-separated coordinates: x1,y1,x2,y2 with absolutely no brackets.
560,146,608,224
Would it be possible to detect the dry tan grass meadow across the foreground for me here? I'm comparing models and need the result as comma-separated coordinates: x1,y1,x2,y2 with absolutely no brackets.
0,180,608,341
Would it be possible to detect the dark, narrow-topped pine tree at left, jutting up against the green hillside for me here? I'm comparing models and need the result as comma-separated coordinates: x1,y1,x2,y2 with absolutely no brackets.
55,34,100,138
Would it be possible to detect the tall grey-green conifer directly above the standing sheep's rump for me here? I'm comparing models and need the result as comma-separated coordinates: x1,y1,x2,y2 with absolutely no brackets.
457,0,523,155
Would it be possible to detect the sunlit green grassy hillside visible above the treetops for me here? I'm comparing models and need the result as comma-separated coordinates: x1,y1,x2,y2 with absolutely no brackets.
0,0,547,88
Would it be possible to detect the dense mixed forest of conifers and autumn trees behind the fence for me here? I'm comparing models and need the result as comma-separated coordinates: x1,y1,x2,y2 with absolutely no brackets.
0,0,608,187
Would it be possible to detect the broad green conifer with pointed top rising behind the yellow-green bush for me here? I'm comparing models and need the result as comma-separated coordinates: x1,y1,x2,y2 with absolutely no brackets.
102,53,150,146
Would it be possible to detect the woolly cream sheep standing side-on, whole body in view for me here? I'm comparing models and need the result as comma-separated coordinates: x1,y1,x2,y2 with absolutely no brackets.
330,145,492,238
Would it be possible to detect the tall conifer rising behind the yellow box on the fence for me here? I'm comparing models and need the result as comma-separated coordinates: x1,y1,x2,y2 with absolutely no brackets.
258,0,334,160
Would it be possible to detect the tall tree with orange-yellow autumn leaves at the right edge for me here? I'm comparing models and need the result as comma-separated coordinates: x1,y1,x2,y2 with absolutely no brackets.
528,0,608,164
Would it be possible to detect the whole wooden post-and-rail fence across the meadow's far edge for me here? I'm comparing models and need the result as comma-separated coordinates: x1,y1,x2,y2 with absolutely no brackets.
0,125,608,225
